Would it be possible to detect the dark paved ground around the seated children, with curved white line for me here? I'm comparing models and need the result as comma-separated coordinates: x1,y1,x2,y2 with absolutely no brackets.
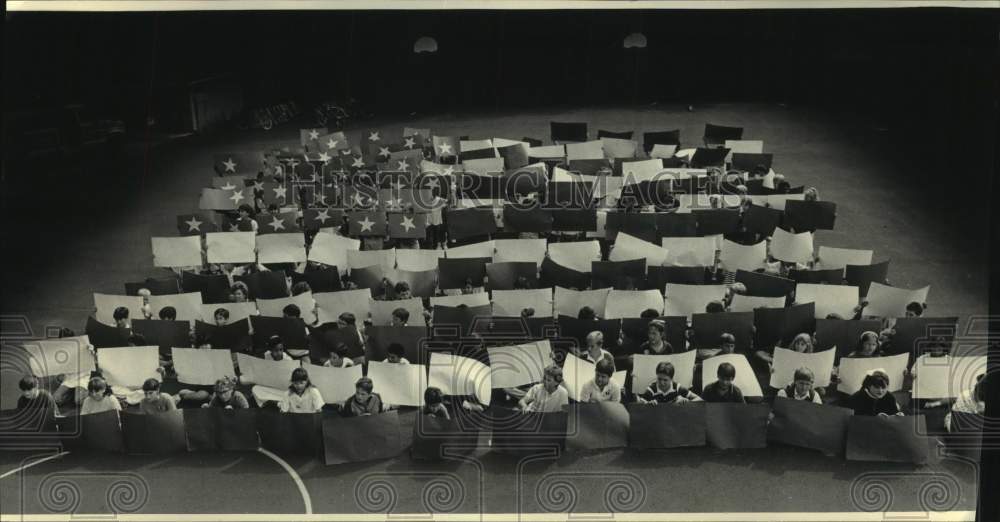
0,105,989,515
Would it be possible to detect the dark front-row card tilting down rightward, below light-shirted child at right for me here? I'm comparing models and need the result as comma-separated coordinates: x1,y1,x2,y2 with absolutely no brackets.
767,397,854,456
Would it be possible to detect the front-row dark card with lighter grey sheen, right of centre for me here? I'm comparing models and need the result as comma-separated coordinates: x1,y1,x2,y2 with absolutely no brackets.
566,401,630,451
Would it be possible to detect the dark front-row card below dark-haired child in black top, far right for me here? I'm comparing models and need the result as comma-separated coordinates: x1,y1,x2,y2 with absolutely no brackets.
846,415,928,464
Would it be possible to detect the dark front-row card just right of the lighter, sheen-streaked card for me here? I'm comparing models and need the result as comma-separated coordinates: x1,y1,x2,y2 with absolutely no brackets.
625,401,707,449
